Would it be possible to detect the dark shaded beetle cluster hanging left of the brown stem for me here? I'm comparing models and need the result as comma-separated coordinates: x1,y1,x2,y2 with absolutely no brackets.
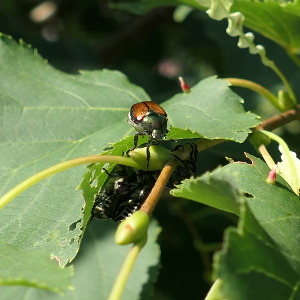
92,165,155,222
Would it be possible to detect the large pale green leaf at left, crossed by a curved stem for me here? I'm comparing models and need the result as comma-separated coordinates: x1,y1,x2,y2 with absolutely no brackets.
0,36,149,272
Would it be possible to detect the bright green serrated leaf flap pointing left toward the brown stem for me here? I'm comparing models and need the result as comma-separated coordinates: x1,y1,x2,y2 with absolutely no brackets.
171,170,241,215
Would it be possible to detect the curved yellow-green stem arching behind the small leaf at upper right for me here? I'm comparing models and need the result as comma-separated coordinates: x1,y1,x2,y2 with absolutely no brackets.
224,78,281,111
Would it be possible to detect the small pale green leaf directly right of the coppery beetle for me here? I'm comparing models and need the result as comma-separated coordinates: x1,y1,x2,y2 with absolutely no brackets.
162,77,259,143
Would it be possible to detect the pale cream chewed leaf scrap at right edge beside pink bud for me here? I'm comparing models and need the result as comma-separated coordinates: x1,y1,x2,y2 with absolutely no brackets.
277,145,300,194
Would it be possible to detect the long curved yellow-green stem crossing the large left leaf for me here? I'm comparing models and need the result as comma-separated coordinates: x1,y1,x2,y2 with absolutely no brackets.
0,155,141,209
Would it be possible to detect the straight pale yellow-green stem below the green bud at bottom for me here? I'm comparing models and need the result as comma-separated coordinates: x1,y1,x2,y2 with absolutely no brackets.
108,236,147,300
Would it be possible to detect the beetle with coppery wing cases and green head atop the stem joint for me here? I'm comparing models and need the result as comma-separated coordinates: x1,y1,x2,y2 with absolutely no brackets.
127,101,168,168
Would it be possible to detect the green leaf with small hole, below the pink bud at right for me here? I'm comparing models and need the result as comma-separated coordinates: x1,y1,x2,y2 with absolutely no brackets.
218,156,300,274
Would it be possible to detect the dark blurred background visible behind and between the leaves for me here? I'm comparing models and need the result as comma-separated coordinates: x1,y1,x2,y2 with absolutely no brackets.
0,0,300,300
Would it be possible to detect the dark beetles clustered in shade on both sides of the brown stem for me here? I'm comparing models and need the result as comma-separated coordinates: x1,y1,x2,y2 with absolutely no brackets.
92,144,198,222
